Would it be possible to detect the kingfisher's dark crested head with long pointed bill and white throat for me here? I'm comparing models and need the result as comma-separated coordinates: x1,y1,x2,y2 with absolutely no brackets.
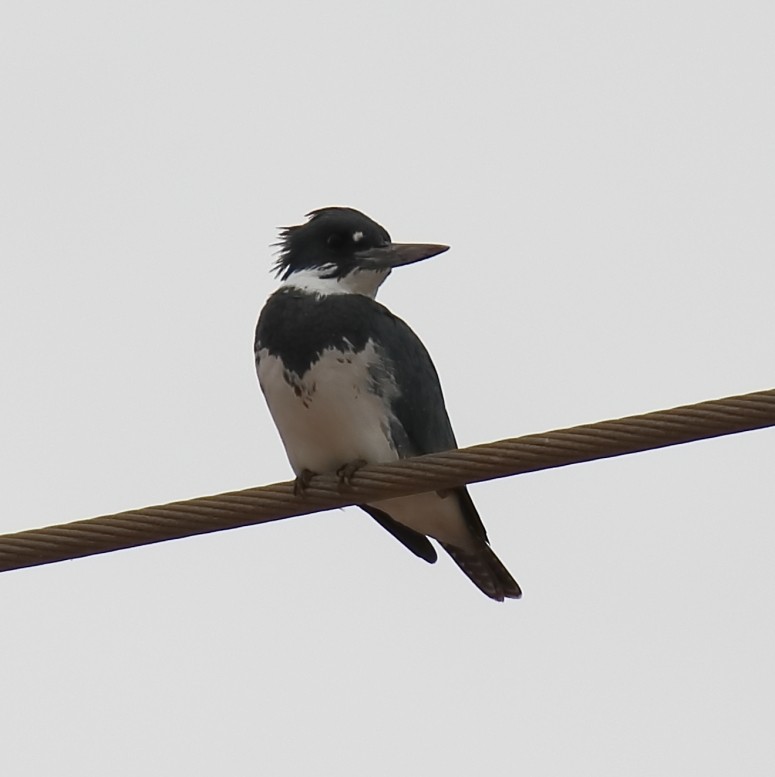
275,208,449,297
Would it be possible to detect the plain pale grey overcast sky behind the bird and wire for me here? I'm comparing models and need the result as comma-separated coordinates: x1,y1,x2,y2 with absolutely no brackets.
0,0,775,777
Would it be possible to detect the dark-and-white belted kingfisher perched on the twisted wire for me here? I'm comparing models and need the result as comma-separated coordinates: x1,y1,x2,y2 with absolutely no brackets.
255,208,522,601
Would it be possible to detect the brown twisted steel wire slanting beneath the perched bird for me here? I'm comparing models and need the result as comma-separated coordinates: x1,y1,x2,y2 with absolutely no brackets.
0,389,775,572
